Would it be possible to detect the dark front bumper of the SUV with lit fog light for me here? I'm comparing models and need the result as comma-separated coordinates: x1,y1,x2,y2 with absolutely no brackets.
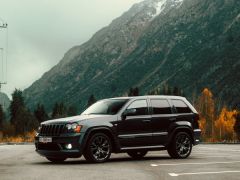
35,133,83,158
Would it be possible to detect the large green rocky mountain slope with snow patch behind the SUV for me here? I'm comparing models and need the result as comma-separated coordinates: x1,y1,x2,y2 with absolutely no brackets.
24,0,240,110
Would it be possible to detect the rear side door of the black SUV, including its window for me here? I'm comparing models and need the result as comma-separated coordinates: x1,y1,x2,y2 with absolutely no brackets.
150,99,176,145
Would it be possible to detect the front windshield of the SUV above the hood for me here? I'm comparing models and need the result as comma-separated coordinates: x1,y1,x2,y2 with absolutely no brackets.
82,99,128,115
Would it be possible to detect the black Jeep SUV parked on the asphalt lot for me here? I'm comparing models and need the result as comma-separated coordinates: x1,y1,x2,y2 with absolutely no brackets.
35,96,201,162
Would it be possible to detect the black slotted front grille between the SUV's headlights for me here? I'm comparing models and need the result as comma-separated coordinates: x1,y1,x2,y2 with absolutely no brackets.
40,124,65,136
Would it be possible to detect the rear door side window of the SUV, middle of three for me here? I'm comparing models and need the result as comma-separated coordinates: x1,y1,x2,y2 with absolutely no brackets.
151,99,172,114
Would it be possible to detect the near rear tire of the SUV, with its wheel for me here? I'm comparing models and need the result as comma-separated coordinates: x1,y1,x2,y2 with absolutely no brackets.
167,132,192,159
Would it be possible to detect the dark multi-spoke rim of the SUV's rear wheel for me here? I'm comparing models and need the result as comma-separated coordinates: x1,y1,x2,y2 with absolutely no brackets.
176,134,191,157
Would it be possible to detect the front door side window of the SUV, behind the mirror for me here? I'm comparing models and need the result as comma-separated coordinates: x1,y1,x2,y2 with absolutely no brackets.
127,100,148,116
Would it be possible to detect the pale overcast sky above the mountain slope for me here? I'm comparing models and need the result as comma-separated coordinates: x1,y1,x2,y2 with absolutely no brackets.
0,0,141,96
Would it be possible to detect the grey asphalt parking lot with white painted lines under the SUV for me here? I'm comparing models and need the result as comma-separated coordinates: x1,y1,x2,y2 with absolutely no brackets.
0,145,240,180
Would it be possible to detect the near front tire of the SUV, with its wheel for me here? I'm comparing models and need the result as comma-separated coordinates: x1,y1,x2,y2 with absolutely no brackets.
83,133,112,163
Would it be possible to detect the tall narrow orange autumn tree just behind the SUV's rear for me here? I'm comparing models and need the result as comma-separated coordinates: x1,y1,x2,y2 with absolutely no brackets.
197,88,215,141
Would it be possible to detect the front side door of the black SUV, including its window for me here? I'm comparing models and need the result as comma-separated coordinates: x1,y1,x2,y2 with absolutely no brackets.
117,99,152,147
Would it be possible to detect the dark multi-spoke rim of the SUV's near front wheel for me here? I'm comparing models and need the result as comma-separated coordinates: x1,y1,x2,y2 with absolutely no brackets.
91,136,110,161
